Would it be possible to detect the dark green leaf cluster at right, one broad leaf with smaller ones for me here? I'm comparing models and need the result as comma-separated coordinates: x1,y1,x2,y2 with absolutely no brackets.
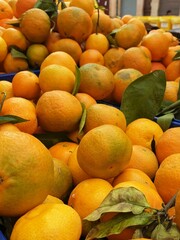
120,70,180,131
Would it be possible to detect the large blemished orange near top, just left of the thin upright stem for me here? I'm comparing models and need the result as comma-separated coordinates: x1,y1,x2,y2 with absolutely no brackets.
56,7,92,43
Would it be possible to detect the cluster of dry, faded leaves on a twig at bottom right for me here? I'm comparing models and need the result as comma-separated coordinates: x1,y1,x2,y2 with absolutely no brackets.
83,187,180,240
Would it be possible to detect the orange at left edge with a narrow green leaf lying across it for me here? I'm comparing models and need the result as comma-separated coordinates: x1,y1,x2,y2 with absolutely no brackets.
1,97,38,134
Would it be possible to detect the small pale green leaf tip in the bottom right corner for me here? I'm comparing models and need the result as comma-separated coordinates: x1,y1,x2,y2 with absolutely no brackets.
151,223,180,240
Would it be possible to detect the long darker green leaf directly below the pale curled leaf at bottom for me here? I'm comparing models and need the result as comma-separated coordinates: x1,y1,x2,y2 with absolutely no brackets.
85,212,153,240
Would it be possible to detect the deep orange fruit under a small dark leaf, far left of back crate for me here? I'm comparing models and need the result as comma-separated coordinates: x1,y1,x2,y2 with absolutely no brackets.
3,52,29,73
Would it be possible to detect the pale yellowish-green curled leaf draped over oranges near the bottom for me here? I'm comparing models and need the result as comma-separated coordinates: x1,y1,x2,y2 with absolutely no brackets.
85,187,150,221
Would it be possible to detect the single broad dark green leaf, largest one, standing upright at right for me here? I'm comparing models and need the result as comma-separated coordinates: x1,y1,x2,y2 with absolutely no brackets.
120,70,166,124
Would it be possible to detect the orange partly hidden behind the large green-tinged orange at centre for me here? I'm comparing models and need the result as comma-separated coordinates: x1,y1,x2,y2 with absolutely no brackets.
83,103,126,133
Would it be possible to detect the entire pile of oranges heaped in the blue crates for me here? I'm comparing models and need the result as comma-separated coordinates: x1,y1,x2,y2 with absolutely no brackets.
0,0,180,240
